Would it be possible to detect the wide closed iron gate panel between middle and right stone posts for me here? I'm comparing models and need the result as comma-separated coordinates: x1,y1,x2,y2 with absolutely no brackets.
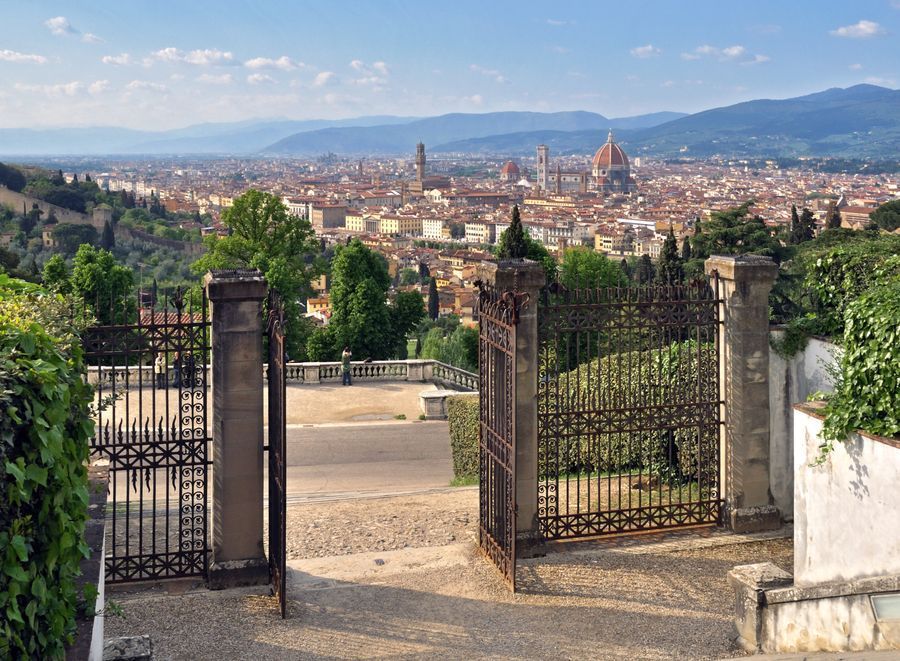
538,278,722,539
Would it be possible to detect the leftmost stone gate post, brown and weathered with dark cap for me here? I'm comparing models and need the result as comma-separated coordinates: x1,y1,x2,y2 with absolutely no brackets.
205,271,269,589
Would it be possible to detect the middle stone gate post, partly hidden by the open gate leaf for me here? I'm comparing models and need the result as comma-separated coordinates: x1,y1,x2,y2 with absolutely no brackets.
478,260,546,542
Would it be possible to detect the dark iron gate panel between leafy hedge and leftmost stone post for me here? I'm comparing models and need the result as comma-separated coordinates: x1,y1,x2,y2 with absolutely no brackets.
82,290,210,583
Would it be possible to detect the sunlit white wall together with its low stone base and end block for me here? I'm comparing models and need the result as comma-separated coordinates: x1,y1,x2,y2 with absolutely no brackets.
728,404,900,653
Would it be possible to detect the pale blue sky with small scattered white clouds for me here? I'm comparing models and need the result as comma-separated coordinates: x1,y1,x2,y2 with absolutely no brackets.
0,0,900,129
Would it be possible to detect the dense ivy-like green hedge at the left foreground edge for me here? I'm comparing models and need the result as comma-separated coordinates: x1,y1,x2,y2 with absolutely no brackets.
0,276,94,659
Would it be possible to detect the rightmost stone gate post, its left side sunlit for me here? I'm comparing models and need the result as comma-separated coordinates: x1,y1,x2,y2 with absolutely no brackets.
706,255,781,532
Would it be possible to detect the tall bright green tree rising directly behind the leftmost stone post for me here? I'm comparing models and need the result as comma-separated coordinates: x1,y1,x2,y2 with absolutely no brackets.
191,189,325,360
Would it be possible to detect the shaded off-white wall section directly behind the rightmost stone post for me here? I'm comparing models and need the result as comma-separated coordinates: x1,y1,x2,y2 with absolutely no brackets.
769,336,837,521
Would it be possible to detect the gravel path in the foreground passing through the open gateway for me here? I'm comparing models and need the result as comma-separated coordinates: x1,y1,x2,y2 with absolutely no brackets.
106,490,792,659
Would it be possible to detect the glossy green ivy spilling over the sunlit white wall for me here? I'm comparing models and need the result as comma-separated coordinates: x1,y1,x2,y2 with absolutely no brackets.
822,278,900,452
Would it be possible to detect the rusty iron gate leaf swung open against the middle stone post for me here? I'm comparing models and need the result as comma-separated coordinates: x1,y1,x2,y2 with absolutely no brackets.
476,283,521,591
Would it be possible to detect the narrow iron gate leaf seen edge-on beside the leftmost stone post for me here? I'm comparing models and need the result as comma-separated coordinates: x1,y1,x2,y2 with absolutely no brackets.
267,290,287,618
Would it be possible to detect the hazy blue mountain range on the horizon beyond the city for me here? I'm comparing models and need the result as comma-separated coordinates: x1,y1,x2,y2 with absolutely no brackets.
0,85,900,159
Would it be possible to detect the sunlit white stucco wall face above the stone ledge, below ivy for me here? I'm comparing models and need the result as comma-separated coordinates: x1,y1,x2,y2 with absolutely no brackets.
793,410,900,586
